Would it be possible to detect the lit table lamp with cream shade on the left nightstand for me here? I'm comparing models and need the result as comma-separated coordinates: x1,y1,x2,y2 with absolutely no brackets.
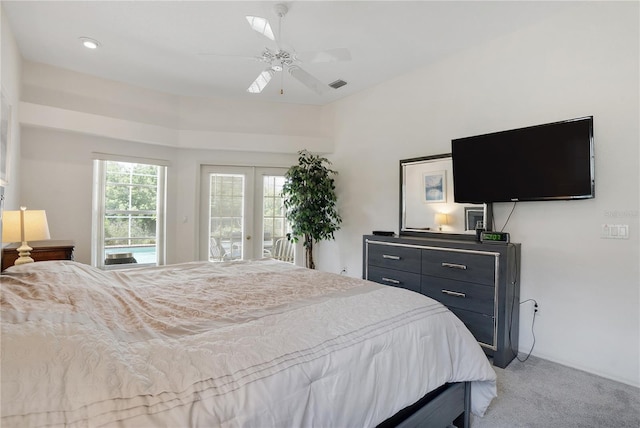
2,207,51,265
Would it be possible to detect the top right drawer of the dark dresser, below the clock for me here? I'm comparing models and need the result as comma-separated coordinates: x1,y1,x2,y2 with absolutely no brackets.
422,249,495,285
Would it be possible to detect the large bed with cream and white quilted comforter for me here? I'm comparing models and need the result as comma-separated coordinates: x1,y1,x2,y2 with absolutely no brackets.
0,259,496,428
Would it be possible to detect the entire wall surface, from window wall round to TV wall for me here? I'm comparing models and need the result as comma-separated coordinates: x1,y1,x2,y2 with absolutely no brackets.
7,2,640,385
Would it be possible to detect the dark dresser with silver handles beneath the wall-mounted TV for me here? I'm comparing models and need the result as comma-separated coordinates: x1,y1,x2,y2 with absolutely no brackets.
363,235,520,368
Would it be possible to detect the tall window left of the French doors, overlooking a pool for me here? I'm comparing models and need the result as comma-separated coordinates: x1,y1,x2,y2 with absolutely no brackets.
92,156,167,269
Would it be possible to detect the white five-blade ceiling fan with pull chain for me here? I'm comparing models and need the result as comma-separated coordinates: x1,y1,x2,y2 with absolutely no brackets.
246,3,351,95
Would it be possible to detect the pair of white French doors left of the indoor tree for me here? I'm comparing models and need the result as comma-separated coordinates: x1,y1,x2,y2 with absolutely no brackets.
200,165,289,262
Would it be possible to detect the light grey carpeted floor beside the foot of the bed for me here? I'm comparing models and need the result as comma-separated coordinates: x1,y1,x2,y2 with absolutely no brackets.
471,357,640,428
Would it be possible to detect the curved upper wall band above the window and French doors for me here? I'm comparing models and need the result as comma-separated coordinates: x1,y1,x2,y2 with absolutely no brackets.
20,61,333,153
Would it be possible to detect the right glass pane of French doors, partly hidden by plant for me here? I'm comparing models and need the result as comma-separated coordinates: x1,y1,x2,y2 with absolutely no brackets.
262,175,290,257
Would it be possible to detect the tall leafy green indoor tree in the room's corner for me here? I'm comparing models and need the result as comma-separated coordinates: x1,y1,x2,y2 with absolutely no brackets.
282,150,342,269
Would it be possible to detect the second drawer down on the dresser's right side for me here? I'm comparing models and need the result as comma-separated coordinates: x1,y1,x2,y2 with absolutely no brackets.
420,275,495,316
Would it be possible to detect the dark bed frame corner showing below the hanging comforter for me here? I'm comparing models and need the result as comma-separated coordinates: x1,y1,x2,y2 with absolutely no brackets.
377,382,471,428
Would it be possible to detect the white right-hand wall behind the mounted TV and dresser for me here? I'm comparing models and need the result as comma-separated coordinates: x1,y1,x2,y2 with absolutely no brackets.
317,2,640,385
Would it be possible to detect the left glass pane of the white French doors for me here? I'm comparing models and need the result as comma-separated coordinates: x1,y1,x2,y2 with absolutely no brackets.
209,174,245,261
